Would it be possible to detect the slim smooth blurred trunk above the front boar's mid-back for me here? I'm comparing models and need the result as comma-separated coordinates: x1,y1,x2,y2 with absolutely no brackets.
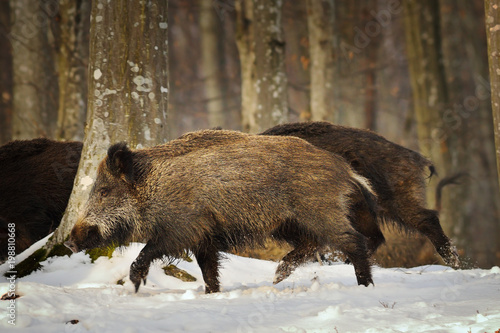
199,0,228,128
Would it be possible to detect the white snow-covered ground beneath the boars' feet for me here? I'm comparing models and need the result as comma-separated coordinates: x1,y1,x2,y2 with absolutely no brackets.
0,237,500,333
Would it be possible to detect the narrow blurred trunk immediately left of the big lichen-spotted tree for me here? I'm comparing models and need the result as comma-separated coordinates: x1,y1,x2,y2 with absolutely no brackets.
56,0,90,141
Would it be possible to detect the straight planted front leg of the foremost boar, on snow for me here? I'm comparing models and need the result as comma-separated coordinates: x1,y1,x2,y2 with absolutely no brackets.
194,242,220,294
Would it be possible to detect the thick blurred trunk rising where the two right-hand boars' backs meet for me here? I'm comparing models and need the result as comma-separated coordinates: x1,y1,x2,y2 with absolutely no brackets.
235,0,288,133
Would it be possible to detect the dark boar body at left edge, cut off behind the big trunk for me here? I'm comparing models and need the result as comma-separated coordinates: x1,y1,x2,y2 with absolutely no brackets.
0,138,82,261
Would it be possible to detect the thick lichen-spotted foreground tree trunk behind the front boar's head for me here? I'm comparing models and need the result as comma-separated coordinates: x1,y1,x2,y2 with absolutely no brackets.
46,0,168,249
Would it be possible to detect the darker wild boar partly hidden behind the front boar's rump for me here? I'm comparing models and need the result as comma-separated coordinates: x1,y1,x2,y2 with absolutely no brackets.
261,122,460,268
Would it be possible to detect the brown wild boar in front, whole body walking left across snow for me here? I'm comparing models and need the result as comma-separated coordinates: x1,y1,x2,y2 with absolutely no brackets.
66,130,377,293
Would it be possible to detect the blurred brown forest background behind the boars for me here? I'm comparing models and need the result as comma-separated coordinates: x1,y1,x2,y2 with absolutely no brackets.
0,0,500,267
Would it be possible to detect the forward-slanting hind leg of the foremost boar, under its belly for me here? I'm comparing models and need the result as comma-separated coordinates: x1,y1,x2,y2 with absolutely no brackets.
273,242,317,284
